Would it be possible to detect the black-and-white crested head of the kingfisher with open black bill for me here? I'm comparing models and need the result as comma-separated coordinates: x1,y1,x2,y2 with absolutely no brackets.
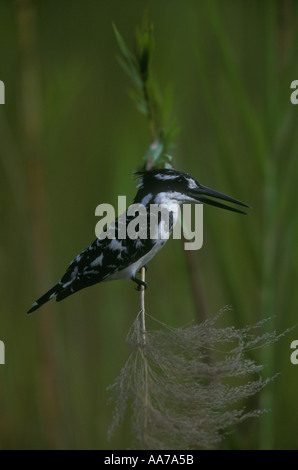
134,169,250,214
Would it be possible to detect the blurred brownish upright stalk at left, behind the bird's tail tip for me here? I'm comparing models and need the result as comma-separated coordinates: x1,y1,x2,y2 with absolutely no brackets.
16,0,63,448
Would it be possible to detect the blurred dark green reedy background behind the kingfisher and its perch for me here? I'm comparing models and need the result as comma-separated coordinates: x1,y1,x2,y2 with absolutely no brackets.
0,0,298,449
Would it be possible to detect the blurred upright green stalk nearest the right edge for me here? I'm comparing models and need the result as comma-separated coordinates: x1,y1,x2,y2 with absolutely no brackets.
260,1,279,449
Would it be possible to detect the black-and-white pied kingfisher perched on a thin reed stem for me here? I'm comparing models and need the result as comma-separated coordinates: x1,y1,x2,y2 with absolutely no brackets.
27,168,250,313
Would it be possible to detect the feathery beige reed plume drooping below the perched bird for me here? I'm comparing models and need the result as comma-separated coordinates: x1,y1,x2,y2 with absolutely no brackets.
108,308,288,449
